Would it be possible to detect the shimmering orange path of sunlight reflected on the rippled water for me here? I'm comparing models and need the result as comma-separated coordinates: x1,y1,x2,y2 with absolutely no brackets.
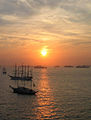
36,69,57,120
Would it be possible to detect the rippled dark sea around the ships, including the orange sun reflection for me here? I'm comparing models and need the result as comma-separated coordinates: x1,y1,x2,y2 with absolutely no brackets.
0,68,91,120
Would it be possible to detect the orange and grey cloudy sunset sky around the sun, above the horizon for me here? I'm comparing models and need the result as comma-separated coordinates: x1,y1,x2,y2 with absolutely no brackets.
0,0,91,65
